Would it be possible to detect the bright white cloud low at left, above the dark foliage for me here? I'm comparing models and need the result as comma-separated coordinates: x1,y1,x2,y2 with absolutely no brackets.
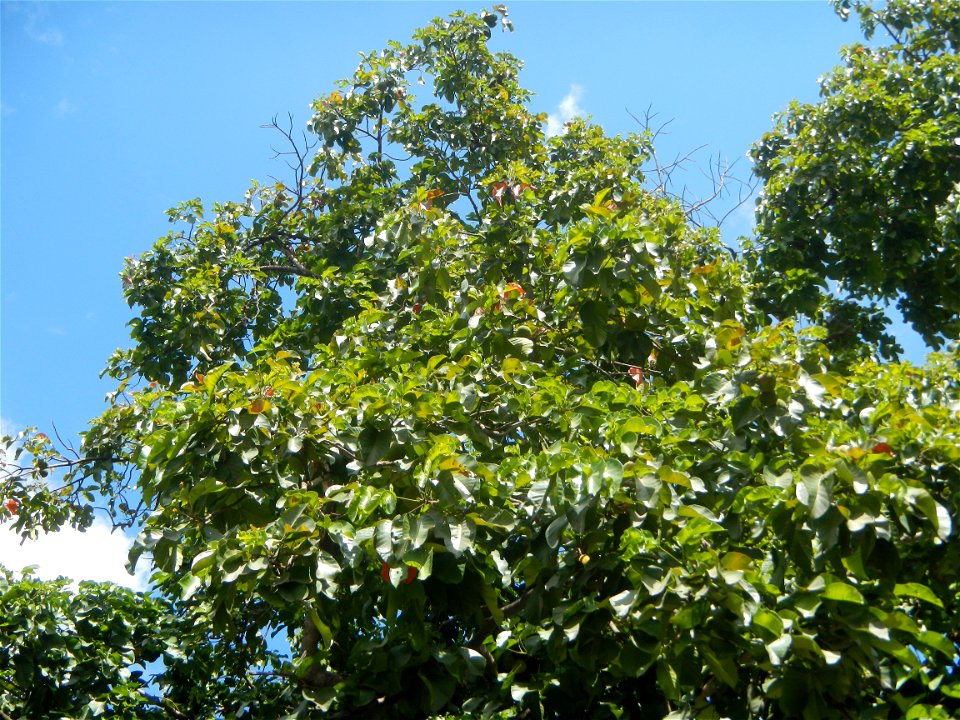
0,519,149,590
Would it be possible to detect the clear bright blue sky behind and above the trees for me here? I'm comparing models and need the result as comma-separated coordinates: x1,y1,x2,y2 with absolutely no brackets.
0,0,922,580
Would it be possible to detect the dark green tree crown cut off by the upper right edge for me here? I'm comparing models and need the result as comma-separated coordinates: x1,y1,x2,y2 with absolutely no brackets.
753,0,960,355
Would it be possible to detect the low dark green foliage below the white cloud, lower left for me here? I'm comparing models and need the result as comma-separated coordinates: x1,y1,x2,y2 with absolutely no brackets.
0,568,289,720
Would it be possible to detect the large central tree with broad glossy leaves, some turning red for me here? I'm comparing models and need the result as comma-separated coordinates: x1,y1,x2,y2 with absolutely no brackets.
0,8,960,719
